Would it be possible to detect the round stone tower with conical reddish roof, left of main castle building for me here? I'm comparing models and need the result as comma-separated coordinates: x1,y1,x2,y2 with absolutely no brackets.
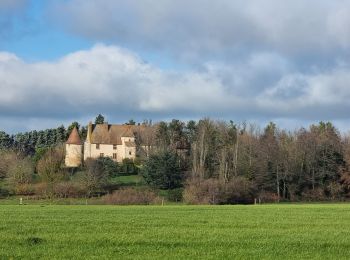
65,127,83,167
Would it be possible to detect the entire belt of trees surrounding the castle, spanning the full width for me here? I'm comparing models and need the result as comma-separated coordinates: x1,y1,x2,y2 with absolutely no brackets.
0,117,350,204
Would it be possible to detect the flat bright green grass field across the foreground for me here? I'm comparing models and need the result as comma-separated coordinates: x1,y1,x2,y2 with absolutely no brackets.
0,204,350,259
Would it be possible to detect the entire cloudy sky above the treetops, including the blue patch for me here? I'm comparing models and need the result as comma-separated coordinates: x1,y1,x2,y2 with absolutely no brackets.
0,0,350,133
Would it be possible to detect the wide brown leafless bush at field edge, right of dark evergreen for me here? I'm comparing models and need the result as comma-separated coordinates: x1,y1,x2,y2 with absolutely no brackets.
183,177,254,204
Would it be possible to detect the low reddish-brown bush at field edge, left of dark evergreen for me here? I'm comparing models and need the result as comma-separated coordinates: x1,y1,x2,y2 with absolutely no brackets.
102,188,160,205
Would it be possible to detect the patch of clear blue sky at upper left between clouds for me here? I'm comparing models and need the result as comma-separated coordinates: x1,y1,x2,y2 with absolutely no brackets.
0,0,89,62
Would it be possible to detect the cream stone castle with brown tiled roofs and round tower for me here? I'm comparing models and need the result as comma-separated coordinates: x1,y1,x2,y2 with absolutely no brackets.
65,123,142,167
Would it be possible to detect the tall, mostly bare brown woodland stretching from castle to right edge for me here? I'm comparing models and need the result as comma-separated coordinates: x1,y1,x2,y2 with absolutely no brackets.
136,119,350,203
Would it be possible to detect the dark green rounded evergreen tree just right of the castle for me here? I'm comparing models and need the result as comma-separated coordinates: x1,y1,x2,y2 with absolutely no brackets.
142,151,184,189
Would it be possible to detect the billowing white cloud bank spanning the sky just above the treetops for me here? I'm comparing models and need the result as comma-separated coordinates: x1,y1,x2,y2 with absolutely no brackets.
0,45,350,133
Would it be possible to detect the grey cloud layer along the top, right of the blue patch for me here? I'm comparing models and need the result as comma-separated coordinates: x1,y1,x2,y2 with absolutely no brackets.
51,0,350,61
